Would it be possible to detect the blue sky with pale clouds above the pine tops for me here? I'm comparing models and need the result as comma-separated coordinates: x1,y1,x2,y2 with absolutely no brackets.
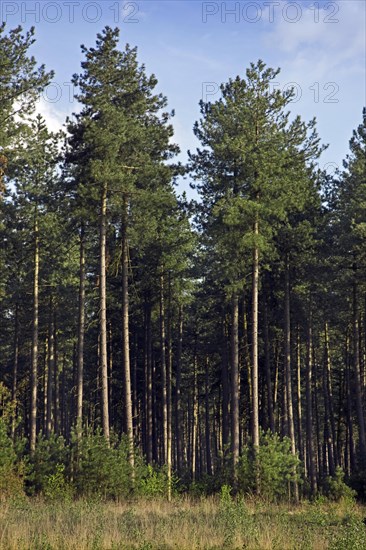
0,0,366,198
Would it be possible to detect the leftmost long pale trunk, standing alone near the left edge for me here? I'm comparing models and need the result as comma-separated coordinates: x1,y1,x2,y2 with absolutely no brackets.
29,213,39,454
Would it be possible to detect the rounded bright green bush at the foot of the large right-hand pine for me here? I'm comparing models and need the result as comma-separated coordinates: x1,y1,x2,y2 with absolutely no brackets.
238,432,300,501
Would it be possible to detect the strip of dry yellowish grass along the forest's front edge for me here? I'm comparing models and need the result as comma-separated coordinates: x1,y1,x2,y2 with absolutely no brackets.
0,497,366,550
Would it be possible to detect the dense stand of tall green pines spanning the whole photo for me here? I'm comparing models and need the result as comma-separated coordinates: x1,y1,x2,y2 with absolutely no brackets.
0,25,366,501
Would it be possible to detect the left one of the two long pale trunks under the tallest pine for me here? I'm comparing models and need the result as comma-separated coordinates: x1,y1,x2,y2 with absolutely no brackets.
99,185,109,443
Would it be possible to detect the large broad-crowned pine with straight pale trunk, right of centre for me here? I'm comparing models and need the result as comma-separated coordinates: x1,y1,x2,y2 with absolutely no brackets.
190,61,320,486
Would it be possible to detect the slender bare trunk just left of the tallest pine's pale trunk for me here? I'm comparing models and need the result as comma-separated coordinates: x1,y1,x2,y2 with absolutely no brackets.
76,223,85,438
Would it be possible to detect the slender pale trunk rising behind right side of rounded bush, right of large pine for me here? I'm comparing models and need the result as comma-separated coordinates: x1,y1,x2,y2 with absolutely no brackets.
285,264,299,502
